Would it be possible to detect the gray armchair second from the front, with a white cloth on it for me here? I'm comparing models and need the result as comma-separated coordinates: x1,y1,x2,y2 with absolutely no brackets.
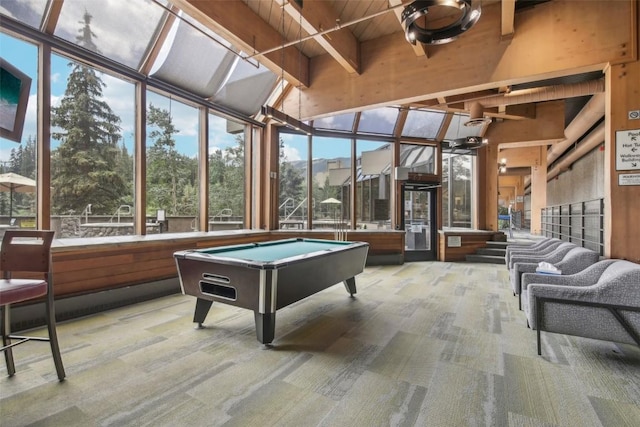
509,243,600,309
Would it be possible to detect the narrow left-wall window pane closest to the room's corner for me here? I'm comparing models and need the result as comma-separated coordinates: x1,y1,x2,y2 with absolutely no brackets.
209,114,245,230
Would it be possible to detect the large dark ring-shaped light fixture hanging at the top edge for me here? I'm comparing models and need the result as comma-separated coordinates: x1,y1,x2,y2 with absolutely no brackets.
401,0,482,44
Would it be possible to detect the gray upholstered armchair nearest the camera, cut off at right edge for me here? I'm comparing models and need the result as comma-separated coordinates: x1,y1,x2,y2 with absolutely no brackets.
522,260,640,354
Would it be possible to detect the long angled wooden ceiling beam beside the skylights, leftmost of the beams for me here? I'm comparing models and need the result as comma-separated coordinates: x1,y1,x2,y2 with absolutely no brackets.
172,0,309,87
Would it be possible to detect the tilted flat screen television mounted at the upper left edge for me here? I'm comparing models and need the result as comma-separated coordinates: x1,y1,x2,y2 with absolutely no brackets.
0,58,31,142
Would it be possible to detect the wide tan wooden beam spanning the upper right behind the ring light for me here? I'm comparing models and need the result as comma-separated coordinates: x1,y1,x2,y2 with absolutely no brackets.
285,1,635,120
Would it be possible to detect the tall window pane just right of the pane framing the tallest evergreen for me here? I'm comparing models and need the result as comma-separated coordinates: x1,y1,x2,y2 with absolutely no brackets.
147,91,198,233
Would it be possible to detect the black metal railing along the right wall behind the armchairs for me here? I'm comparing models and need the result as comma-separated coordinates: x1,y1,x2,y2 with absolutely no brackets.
542,199,604,255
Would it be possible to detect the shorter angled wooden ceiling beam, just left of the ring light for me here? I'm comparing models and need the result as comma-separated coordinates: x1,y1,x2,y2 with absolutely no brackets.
276,0,360,74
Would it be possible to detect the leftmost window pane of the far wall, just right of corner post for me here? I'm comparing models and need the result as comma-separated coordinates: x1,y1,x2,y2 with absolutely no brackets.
278,133,308,229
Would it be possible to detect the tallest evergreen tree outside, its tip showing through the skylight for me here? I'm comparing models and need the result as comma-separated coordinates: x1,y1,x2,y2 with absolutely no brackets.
51,12,125,214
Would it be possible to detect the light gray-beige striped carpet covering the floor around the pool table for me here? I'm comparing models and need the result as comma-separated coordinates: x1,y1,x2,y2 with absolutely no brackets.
0,262,640,427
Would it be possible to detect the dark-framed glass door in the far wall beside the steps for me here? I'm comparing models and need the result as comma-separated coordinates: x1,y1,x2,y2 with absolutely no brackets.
402,184,437,261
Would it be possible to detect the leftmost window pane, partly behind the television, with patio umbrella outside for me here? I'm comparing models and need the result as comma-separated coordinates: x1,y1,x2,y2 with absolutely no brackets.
0,33,38,228
